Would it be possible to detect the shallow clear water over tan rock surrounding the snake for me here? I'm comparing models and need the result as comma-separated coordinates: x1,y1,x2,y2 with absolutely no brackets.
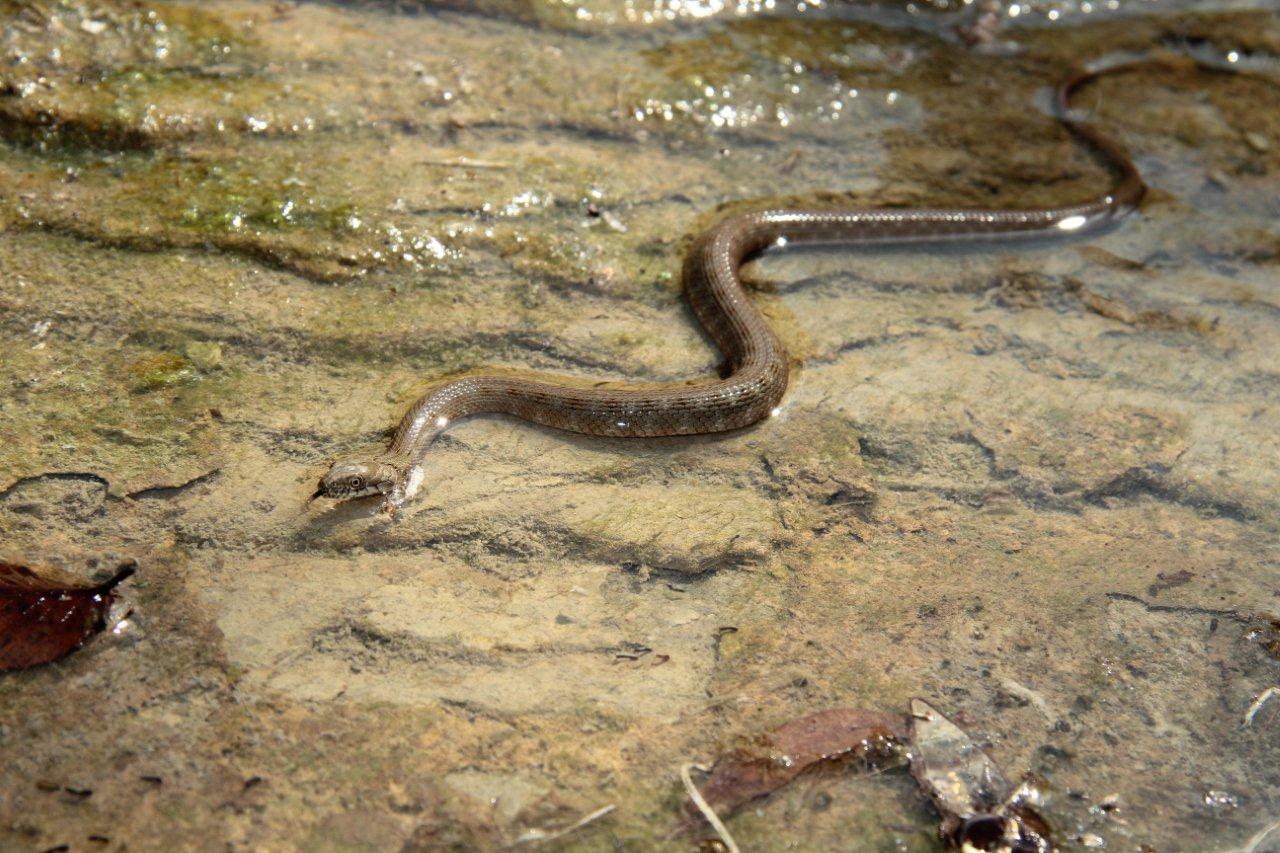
0,0,1280,852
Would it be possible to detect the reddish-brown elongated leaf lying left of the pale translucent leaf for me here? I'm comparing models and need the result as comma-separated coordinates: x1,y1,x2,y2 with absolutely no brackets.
700,708,906,817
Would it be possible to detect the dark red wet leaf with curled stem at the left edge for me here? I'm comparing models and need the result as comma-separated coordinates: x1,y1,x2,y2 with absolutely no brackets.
0,560,137,672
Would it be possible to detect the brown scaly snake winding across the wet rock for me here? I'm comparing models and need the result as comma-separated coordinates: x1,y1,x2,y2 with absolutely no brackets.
308,60,1151,514
